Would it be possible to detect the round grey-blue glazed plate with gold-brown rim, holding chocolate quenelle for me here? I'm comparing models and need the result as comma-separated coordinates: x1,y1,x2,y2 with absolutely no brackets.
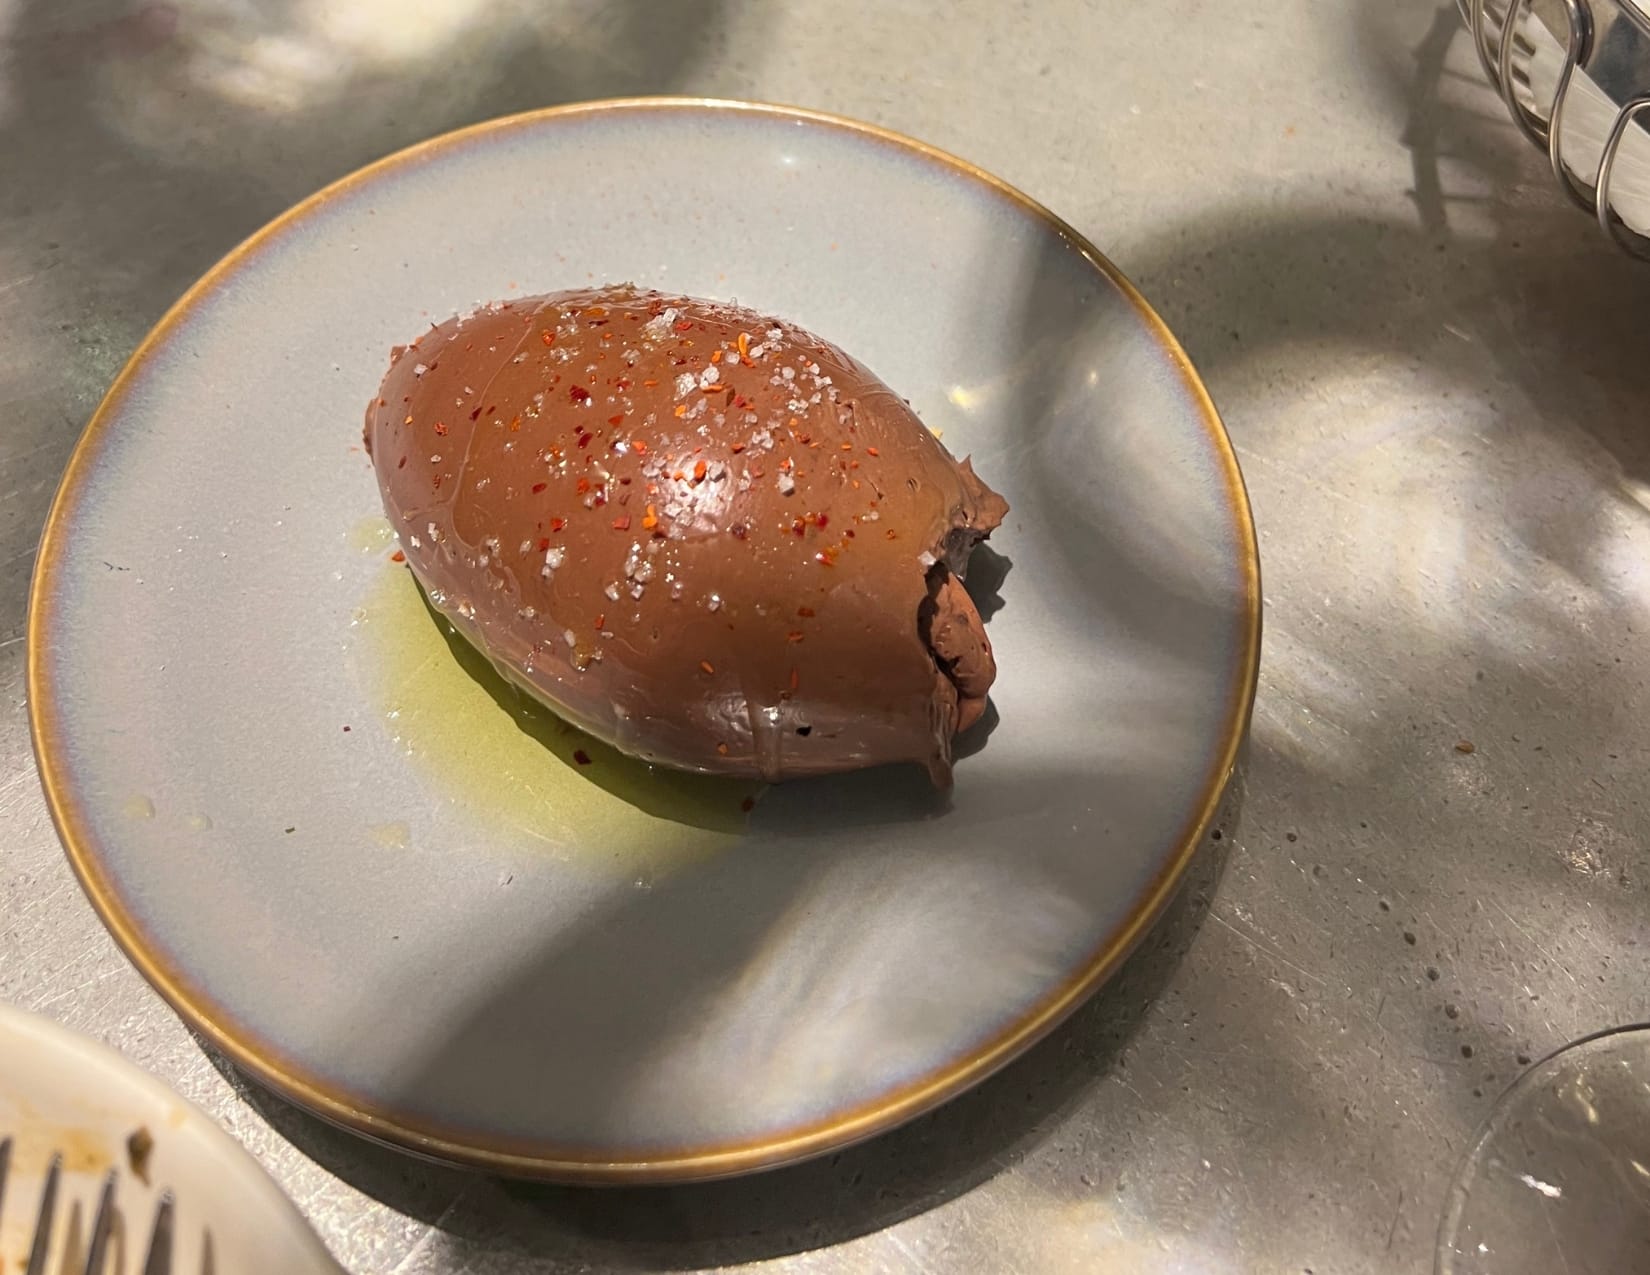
30,99,1259,1181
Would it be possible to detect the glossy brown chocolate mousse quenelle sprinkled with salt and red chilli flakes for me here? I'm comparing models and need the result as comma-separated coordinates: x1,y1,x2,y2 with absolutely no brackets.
366,287,1008,785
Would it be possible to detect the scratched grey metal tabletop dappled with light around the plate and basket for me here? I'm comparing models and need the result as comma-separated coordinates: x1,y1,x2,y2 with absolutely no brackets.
0,0,1650,1275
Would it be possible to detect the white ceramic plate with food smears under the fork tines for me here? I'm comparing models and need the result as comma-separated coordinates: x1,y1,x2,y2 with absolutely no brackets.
0,1004,338,1275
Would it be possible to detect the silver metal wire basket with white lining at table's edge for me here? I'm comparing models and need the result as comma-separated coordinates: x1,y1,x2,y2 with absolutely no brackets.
1457,0,1650,259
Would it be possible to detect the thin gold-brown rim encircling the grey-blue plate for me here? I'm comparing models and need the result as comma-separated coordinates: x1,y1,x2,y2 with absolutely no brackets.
26,97,1261,1184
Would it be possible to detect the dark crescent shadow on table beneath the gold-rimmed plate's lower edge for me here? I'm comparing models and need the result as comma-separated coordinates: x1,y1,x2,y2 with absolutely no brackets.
206,772,1242,1268
